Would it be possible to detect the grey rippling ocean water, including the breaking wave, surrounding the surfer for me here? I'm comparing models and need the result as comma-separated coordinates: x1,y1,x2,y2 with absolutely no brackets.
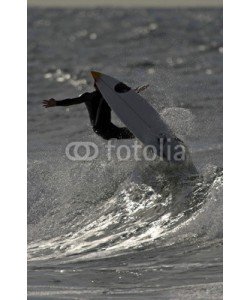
28,8,223,299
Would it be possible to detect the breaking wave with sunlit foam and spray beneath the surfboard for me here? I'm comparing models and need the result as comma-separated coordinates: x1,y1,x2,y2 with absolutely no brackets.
29,151,222,260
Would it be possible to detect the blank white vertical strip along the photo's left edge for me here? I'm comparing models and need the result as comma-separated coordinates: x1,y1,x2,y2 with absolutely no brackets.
0,1,27,300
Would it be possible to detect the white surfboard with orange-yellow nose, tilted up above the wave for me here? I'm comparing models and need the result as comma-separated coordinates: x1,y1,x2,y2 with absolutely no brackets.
91,71,191,163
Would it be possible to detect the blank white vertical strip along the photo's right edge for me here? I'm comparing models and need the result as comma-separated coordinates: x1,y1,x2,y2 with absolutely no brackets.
224,1,250,299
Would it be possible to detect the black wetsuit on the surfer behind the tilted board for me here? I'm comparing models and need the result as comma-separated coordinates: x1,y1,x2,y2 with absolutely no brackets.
56,91,134,140
